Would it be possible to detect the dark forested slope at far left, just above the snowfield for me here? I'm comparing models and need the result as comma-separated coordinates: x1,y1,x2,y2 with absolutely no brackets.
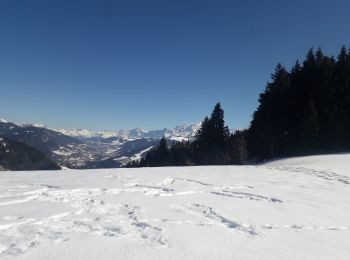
0,136,61,171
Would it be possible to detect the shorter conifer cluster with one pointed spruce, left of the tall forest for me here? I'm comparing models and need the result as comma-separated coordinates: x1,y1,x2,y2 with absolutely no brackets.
128,103,247,167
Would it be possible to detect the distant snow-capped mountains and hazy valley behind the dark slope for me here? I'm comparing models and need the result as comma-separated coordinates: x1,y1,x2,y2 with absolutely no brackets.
0,119,200,171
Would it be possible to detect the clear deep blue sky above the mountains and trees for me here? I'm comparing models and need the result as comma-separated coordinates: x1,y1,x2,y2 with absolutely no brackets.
0,0,350,130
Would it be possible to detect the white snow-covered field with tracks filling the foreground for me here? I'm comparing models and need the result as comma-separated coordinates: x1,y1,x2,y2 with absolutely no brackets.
0,154,350,260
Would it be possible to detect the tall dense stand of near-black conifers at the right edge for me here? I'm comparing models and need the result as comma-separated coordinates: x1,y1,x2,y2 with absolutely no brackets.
247,47,350,160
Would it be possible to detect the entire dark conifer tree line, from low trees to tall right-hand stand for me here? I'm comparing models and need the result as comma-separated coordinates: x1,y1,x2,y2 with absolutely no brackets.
128,46,350,167
